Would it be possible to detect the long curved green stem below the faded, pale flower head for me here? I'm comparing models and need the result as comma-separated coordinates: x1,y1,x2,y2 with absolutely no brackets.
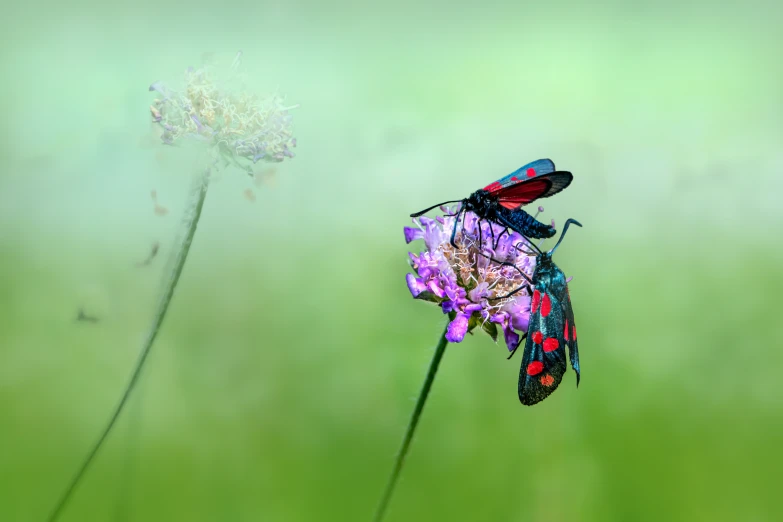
47,172,209,522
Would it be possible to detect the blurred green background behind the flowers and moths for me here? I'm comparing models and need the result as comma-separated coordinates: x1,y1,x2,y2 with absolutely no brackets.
0,0,783,522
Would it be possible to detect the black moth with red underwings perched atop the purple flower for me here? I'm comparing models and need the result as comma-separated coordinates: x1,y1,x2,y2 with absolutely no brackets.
411,159,574,245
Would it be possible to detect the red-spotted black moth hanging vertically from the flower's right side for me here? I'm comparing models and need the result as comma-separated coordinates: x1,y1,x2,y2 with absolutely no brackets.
518,219,582,406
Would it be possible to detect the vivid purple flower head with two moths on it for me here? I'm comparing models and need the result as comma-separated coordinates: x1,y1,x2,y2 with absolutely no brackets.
403,208,536,350
